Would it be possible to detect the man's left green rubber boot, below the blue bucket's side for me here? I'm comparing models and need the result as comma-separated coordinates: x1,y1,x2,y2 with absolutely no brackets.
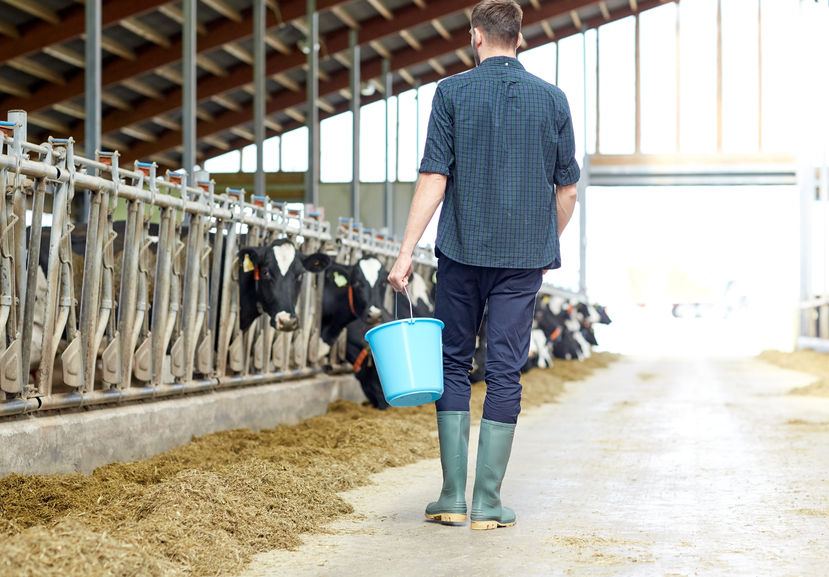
426,411,469,525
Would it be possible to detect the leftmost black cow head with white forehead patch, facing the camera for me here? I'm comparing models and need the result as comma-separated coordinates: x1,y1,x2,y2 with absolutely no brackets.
239,239,331,331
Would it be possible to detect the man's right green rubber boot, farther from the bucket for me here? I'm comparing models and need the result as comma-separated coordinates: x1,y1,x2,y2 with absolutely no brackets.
471,419,515,531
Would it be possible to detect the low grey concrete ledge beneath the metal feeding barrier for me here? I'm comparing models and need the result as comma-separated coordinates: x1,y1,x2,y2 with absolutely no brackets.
0,375,365,475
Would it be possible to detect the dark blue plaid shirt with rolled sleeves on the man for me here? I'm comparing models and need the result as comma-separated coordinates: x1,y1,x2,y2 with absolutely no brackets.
420,56,579,269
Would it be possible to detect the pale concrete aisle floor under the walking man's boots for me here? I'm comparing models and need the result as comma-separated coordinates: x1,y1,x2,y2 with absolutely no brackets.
238,358,829,577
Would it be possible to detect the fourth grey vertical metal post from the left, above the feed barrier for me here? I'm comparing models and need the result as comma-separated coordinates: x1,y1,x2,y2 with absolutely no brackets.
305,0,320,205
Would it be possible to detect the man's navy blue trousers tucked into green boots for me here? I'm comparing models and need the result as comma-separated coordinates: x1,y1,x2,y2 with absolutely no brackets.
435,253,543,424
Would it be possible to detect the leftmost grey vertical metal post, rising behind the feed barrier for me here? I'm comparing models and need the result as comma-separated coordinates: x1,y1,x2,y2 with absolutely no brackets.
81,0,101,221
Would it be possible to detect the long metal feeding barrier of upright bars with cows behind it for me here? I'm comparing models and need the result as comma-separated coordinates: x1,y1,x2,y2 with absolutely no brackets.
0,111,584,417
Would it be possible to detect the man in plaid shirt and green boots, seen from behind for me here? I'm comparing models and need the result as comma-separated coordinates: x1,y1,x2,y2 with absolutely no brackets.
389,0,579,529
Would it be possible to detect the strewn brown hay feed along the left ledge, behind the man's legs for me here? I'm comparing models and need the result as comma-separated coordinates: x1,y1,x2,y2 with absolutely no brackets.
0,353,616,577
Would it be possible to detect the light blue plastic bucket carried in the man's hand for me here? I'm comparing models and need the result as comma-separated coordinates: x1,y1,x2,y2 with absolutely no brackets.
366,293,443,407
